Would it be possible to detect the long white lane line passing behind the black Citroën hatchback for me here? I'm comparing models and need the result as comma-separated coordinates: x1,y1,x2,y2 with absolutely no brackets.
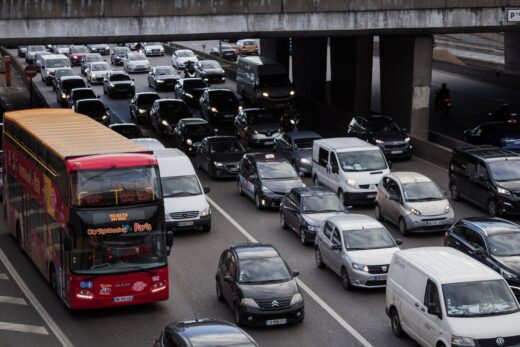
206,196,372,347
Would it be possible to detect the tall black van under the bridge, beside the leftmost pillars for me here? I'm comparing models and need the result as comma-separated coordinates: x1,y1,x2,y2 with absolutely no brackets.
236,56,295,108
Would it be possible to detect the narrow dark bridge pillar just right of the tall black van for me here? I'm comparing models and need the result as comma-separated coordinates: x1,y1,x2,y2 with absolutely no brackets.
292,37,327,101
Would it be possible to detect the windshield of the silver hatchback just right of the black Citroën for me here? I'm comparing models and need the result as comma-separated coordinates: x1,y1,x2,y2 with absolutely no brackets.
343,228,396,251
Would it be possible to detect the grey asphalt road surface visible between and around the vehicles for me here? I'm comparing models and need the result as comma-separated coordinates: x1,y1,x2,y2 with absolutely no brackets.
0,47,504,347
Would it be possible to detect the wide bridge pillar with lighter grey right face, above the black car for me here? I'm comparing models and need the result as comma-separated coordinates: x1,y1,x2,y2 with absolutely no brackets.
379,36,433,140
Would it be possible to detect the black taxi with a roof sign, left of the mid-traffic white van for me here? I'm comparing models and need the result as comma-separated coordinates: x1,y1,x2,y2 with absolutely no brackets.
237,153,304,209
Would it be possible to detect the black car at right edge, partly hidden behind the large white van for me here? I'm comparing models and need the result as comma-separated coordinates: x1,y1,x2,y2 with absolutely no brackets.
444,218,520,298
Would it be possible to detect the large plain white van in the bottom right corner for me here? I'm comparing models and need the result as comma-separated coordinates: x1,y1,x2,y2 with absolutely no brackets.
386,247,520,347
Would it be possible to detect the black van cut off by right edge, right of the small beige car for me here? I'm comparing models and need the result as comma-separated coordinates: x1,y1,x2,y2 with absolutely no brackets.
449,146,520,217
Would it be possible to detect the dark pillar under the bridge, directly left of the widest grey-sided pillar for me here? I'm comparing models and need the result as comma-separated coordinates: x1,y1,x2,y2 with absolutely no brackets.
330,36,374,116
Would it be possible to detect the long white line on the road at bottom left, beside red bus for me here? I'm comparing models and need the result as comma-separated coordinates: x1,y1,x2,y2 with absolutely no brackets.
0,248,74,347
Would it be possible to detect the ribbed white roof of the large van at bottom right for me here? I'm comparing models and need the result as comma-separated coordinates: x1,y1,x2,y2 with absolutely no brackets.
394,247,503,284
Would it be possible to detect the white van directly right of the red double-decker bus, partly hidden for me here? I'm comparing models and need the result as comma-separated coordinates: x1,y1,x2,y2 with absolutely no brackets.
154,148,211,232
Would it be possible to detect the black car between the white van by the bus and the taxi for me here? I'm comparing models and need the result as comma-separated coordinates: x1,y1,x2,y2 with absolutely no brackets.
195,136,246,179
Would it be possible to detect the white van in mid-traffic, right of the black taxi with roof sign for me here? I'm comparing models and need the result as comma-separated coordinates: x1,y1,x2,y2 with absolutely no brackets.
312,137,390,205
